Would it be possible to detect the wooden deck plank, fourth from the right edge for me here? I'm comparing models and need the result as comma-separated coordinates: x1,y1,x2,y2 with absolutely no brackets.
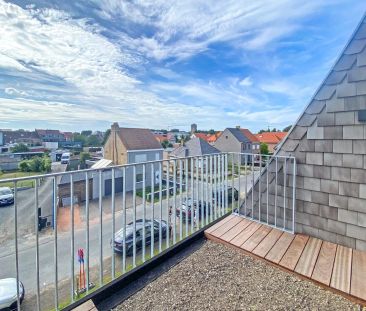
295,237,322,278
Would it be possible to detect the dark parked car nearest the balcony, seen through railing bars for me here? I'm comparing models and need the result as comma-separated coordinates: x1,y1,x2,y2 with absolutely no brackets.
111,219,168,256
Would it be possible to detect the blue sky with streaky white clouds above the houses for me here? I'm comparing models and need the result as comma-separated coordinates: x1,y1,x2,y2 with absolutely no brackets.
0,0,366,131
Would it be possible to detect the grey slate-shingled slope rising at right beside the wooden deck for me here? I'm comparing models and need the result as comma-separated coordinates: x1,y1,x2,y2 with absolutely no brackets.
248,16,366,250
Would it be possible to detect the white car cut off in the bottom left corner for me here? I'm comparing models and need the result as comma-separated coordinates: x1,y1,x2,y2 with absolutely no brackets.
0,278,24,310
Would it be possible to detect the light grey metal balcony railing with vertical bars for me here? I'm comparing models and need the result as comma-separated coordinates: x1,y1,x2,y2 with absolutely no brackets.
0,153,296,310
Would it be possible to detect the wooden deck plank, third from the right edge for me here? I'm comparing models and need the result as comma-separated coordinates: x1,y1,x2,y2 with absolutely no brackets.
311,241,337,286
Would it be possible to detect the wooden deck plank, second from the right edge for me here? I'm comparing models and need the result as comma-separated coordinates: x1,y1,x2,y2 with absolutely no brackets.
330,245,352,293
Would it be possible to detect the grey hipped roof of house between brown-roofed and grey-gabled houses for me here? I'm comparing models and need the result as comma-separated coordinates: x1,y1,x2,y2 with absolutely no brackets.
170,137,220,158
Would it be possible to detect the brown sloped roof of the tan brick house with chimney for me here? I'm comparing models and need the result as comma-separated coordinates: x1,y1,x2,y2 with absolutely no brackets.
118,127,162,150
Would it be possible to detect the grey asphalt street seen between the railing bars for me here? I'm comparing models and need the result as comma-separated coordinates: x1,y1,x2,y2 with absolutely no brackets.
0,173,258,310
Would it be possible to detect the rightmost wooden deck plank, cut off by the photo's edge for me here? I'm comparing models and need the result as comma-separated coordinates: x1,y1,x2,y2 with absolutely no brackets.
351,250,366,300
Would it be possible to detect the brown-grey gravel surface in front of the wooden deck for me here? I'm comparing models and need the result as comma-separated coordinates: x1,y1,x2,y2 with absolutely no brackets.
115,241,366,311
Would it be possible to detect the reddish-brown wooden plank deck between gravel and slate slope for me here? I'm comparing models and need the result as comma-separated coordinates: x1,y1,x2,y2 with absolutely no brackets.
205,215,366,305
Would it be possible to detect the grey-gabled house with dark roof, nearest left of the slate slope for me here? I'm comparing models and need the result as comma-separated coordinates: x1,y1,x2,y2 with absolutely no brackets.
214,126,260,164
